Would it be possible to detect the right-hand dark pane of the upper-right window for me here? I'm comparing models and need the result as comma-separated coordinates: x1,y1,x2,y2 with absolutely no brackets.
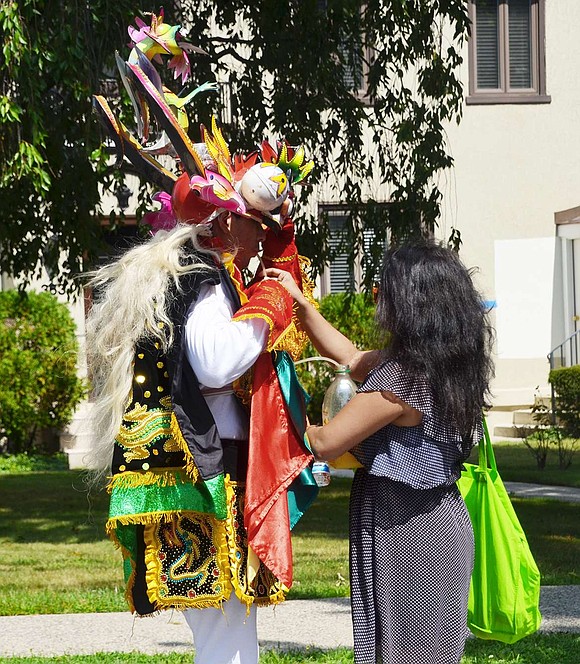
508,0,532,88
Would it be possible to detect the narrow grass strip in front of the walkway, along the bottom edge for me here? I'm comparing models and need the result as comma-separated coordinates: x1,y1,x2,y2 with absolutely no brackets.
0,634,580,664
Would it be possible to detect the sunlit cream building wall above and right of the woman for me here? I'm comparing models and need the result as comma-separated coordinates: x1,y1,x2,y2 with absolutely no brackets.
441,0,580,416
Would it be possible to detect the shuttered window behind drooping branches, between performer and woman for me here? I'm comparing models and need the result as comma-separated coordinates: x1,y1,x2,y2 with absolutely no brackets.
321,205,374,295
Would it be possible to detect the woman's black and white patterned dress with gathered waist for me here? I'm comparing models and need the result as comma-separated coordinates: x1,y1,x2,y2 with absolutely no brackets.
350,361,481,664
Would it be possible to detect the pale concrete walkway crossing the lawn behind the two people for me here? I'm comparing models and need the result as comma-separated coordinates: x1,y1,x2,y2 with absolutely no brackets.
0,482,580,657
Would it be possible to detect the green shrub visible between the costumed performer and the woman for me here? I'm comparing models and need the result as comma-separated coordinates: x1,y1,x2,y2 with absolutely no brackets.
296,293,379,424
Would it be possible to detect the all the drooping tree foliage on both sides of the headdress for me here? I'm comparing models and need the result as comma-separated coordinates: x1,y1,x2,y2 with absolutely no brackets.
0,0,468,296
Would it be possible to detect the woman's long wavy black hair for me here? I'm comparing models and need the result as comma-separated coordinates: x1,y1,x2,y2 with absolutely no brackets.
376,240,494,453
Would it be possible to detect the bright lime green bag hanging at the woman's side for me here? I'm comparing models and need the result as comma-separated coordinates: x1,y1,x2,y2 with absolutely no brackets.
457,421,542,643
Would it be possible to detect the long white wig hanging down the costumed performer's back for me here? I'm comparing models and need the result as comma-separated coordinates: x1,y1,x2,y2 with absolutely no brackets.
86,224,219,485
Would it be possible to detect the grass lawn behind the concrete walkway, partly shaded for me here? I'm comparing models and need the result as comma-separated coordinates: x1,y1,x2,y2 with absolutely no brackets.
0,464,580,615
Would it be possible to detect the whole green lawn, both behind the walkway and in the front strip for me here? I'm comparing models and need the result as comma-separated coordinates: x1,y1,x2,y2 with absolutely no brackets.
0,456,580,664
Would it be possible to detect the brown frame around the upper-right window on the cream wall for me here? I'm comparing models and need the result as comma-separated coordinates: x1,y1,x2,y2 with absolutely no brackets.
465,0,552,105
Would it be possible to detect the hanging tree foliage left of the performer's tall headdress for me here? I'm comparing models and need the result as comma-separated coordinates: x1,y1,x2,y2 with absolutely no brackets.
0,0,152,285
